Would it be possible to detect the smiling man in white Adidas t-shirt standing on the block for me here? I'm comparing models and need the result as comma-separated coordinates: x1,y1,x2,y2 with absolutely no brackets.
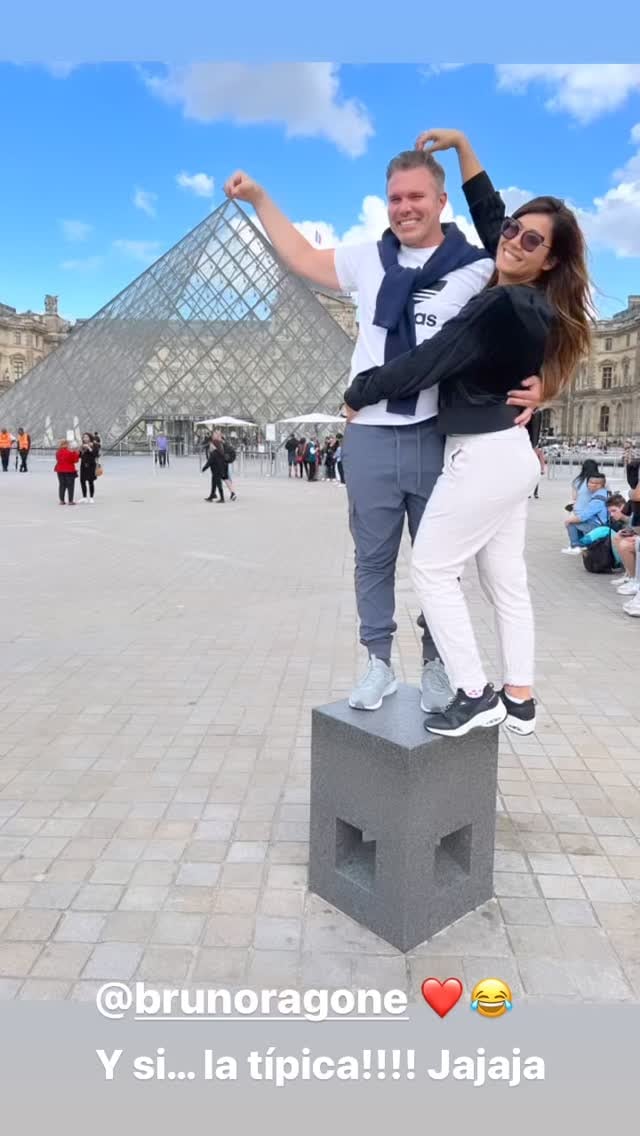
225,142,537,711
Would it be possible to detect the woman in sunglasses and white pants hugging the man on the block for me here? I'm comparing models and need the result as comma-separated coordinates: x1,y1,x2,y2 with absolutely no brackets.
344,130,591,737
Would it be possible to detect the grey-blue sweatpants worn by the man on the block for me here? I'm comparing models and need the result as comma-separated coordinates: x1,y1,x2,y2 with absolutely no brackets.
342,418,444,659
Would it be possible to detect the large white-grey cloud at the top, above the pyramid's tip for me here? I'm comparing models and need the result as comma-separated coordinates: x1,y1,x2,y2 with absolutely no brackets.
144,62,373,158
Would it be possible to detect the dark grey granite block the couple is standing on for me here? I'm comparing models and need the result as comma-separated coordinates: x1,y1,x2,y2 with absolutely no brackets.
309,685,498,951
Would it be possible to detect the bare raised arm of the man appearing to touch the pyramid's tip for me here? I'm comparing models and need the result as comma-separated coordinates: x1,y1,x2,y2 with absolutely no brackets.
224,169,340,291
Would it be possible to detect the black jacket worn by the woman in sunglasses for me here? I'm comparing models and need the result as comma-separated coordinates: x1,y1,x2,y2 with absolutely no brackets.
344,173,554,434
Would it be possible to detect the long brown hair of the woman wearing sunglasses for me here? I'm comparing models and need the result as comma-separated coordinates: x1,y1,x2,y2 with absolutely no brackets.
513,197,596,402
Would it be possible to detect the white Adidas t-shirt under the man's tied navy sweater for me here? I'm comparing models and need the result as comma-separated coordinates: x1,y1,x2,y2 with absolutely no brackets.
334,241,493,426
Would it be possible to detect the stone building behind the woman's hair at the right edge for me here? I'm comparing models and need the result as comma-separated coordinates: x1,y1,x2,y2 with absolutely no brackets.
543,295,640,445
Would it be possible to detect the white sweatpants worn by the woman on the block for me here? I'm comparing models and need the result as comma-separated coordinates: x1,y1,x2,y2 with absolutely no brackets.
412,426,540,691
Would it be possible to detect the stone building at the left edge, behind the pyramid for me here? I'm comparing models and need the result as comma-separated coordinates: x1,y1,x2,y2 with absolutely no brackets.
0,295,72,390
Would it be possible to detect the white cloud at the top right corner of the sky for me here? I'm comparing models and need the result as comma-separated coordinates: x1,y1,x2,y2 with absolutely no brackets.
496,64,640,123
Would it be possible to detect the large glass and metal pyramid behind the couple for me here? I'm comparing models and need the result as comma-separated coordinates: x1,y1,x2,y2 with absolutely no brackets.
0,201,354,448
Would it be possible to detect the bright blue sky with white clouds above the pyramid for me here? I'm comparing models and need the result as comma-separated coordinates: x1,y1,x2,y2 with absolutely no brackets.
0,64,640,318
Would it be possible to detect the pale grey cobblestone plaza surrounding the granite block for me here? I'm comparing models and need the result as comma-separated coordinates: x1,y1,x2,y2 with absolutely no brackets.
0,457,640,1002
